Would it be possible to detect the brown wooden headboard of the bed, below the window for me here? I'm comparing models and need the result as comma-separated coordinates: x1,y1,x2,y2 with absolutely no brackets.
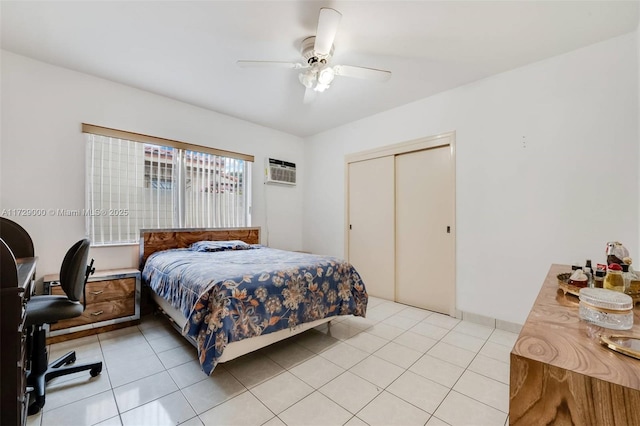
140,227,260,270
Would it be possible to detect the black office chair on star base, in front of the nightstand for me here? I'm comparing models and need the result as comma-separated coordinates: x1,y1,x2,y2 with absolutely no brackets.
25,239,102,414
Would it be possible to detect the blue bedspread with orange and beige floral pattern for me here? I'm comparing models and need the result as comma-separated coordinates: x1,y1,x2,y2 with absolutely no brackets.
142,246,368,374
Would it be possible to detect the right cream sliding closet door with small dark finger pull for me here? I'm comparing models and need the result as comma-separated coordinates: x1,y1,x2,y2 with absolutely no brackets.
395,146,455,315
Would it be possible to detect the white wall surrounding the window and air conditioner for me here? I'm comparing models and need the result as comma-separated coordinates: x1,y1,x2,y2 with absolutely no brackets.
0,51,304,277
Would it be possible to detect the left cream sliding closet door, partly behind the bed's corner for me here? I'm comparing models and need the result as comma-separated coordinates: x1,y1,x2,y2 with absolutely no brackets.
347,155,395,300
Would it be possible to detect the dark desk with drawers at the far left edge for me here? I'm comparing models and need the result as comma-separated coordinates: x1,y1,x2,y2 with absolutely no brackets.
0,257,37,425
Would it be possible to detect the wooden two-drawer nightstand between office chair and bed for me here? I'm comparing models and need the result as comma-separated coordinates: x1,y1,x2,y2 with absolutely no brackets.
44,269,140,344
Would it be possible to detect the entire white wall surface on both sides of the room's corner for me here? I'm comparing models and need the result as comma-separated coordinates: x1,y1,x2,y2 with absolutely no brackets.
0,34,640,323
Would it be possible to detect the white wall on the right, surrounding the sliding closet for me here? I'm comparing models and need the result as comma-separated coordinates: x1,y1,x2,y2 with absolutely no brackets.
304,33,640,323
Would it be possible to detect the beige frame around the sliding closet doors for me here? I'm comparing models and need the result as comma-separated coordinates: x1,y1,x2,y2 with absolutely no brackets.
344,131,458,317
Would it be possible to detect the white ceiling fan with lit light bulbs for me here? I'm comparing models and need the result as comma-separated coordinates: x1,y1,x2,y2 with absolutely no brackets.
237,8,391,103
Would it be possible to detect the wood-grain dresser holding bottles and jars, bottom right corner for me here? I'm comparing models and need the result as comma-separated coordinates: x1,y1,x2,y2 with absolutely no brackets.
509,265,640,426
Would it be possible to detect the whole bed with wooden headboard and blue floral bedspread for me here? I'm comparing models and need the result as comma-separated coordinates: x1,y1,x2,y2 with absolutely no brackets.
140,228,368,374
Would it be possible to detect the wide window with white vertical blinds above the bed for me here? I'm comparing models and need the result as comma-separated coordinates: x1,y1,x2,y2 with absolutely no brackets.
83,124,253,245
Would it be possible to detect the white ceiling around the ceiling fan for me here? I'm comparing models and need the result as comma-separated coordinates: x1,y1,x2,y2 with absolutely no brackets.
0,0,638,136
